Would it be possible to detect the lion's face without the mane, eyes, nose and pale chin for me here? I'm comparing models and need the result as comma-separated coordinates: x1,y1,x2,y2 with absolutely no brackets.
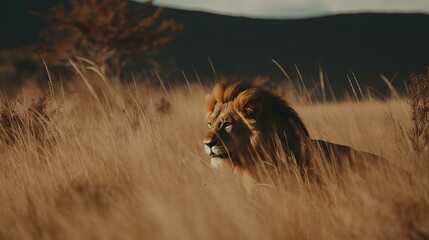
203,102,251,168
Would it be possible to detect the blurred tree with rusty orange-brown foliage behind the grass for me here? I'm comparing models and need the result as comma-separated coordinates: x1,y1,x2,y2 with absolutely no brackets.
30,0,183,79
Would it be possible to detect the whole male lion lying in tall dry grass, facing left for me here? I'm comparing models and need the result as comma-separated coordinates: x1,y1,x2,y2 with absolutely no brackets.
203,80,387,180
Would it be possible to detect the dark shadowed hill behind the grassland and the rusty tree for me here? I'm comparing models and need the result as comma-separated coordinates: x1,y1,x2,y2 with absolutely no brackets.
0,0,429,94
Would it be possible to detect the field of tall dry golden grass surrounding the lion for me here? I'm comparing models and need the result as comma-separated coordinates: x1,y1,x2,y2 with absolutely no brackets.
0,69,429,239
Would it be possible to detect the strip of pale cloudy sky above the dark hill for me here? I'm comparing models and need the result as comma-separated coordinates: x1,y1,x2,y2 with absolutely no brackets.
145,0,429,18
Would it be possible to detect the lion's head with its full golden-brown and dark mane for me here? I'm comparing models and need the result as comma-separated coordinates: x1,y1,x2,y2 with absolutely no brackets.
203,81,308,170
